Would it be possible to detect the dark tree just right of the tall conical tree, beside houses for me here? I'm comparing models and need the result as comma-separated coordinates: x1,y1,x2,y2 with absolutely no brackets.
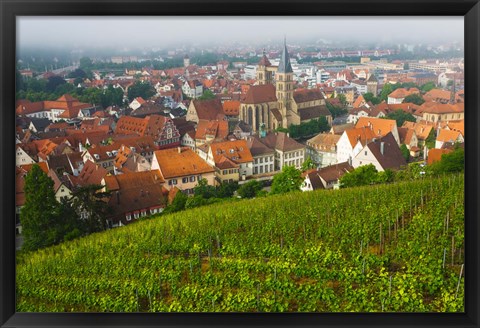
71,185,111,234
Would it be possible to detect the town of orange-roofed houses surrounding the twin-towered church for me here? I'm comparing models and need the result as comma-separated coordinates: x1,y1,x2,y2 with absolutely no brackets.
15,37,464,249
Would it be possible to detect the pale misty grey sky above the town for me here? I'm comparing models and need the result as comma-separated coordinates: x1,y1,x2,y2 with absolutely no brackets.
17,16,464,48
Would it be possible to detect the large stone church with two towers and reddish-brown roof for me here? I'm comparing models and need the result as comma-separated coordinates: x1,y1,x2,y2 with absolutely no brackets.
239,41,332,132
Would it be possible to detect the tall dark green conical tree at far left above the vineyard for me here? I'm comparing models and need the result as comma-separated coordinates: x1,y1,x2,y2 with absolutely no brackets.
20,164,59,251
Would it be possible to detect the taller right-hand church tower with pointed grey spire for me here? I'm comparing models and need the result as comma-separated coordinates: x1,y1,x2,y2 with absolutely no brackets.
275,39,294,128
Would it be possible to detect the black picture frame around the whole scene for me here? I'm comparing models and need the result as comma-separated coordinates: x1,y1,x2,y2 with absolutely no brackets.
0,0,480,327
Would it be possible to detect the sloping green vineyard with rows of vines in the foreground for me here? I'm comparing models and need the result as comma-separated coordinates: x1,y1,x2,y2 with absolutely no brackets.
16,175,464,312
